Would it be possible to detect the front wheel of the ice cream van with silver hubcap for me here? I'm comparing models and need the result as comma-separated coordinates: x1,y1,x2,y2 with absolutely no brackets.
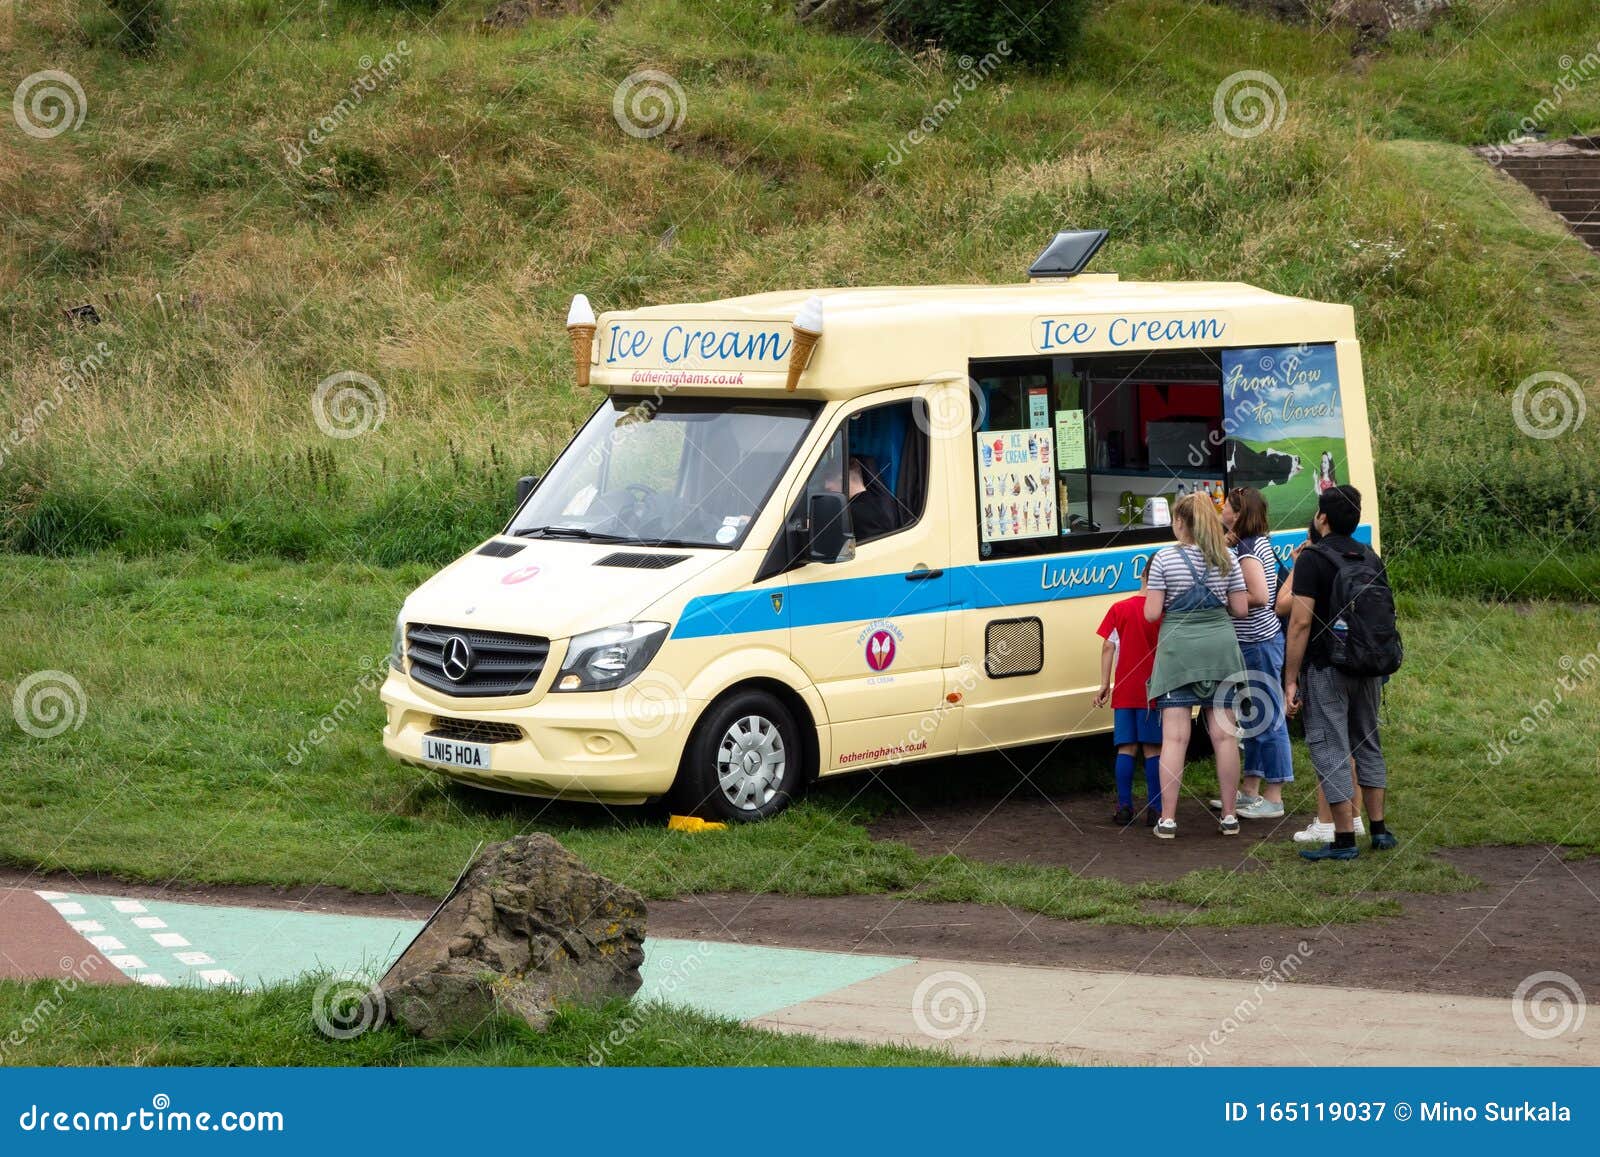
672,691,805,824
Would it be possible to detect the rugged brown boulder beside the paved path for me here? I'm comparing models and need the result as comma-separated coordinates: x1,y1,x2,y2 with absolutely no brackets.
379,834,645,1037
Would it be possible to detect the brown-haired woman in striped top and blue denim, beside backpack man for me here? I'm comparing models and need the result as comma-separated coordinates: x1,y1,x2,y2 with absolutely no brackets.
1211,486,1294,819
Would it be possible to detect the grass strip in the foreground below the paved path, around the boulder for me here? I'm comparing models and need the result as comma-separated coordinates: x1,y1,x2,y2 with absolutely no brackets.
0,976,1024,1067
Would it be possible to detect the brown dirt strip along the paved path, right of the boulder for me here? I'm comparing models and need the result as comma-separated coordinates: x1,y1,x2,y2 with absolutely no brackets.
650,837,1600,997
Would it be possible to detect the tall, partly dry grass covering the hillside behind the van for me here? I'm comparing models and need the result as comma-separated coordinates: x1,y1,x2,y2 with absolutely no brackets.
0,0,1600,588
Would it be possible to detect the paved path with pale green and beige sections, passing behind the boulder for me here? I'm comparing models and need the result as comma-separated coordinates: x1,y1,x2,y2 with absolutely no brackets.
0,890,1600,1066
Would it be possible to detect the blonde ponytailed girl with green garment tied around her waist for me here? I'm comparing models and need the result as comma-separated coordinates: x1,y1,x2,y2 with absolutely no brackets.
1144,494,1250,840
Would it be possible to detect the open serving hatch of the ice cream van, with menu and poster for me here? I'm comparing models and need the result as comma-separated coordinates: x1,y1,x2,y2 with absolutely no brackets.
970,342,1349,558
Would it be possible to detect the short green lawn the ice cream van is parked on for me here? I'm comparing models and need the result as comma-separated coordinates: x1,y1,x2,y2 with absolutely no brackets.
0,554,1600,927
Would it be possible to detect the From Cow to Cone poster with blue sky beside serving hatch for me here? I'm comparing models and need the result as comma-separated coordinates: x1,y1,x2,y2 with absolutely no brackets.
1222,344,1349,530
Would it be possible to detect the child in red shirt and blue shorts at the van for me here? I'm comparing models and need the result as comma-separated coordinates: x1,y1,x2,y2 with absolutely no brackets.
1094,555,1162,827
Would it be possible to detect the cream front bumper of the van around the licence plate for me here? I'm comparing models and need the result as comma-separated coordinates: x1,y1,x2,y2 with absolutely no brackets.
382,672,704,803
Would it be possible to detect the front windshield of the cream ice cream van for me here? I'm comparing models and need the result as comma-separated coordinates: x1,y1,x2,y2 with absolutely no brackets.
509,397,816,547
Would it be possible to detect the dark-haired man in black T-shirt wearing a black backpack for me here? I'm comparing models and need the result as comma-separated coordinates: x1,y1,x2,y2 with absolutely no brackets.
1283,486,1403,861
